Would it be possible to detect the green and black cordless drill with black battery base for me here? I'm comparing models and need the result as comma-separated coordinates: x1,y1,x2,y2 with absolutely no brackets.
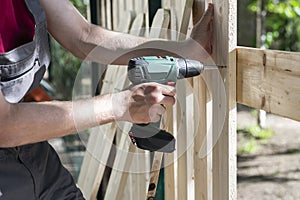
128,56,217,153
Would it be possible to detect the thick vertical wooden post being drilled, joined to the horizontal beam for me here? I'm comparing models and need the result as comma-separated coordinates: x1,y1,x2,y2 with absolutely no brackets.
212,0,237,200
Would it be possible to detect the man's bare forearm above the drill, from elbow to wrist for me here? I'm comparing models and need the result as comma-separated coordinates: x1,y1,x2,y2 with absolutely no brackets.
78,25,191,65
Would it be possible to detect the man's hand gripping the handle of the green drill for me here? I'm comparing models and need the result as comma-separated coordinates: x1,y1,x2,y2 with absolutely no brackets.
112,83,175,123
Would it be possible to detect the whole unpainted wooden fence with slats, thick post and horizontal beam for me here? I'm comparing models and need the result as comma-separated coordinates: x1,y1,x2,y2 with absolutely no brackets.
78,0,300,200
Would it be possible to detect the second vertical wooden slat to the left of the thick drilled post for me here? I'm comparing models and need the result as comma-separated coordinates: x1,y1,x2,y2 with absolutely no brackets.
173,0,194,200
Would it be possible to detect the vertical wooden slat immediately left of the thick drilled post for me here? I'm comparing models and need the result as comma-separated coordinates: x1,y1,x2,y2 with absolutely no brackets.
192,0,211,200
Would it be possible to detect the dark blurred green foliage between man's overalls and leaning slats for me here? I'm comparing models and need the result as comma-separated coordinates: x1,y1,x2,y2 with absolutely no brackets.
49,0,86,100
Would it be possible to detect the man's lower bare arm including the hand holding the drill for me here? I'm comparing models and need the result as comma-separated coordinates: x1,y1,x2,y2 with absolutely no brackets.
0,83,175,147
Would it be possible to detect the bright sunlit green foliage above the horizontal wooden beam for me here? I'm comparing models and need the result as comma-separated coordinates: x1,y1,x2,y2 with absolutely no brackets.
249,0,300,51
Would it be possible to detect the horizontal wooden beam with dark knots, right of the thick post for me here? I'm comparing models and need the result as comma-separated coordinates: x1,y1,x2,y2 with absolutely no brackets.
237,47,300,121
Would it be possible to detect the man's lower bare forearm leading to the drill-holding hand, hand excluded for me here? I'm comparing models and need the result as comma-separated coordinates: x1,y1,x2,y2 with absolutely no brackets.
0,95,115,147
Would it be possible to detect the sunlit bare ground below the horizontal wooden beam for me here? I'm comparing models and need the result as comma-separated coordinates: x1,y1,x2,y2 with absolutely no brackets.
238,111,300,200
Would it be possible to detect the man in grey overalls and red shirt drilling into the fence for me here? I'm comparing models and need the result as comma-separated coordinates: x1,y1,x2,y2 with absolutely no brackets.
0,0,213,200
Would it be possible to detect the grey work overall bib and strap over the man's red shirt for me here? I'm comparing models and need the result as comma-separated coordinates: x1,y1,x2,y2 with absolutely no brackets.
0,0,50,103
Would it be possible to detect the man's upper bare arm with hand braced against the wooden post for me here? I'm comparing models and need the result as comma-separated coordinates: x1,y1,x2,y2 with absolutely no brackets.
40,0,213,65
